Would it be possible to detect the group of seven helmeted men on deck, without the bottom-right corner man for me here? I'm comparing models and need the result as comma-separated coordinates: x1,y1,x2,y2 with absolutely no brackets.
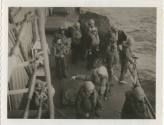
53,19,149,118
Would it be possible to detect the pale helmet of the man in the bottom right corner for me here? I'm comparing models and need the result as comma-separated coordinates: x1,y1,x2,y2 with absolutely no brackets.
133,86,145,100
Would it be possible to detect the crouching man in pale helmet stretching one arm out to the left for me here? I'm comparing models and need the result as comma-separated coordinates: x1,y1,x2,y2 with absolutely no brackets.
72,60,110,100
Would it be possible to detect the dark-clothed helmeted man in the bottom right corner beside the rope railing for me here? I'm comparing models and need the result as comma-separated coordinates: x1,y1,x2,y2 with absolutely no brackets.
121,85,154,119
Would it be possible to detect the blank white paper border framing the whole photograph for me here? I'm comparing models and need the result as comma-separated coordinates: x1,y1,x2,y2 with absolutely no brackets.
0,0,164,125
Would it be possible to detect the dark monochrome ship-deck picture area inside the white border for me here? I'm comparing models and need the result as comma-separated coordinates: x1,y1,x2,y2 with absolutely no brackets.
6,7,157,119
